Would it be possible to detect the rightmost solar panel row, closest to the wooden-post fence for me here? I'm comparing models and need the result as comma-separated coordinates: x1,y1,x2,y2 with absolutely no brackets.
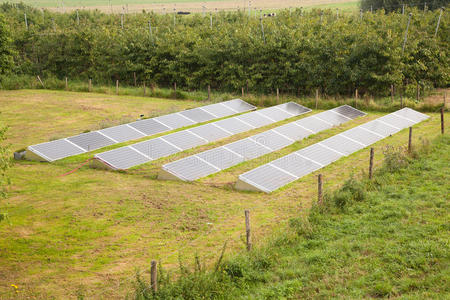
236,108,428,193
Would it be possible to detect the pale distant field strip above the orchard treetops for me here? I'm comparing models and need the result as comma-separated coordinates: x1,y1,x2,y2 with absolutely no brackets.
10,0,358,12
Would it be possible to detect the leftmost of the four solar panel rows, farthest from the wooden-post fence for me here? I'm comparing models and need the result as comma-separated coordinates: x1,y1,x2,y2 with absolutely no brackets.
28,99,256,162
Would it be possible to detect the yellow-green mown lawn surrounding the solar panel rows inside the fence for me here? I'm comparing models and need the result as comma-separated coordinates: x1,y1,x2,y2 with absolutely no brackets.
0,90,446,299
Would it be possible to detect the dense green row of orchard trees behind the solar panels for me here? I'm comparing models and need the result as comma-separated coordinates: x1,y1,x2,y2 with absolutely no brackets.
0,4,450,95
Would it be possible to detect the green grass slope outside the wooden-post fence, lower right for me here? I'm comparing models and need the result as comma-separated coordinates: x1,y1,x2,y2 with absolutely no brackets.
135,135,450,299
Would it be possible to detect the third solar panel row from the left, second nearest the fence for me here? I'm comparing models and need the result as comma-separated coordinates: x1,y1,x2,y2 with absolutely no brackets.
160,105,365,181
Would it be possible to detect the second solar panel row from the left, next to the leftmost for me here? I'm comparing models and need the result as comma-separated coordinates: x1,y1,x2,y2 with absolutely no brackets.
95,102,311,170
